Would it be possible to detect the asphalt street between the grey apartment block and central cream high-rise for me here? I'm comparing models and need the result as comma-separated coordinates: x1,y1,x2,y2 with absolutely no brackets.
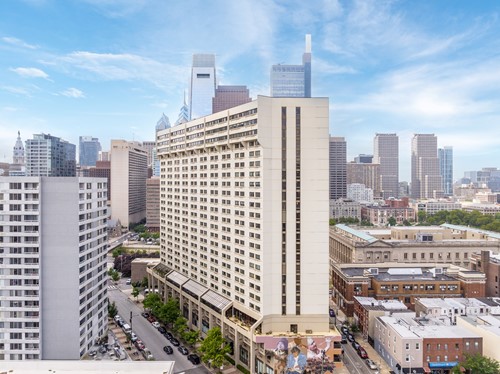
108,280,209,374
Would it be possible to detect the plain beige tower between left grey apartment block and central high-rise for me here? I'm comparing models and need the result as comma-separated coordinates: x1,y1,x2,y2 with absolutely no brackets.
111,140,148,227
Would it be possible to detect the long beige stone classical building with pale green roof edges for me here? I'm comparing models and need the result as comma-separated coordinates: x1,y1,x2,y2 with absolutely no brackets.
329,224,500,267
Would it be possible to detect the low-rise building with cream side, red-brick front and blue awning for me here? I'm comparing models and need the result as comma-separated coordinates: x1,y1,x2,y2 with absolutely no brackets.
374,314,483,374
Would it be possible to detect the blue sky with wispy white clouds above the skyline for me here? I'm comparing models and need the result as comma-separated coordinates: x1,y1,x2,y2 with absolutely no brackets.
0,0,500,180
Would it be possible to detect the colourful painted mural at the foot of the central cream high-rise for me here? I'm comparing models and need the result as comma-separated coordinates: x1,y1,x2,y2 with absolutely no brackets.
257,336,338,374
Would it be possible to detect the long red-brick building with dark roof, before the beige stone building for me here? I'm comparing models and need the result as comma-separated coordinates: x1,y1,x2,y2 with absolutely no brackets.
332,263,485,317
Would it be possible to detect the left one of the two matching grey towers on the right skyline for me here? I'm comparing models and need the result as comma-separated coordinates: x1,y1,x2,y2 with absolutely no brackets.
373,134,399,199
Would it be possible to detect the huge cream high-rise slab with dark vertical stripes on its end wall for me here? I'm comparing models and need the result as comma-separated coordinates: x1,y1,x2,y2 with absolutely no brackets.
149,96,341,373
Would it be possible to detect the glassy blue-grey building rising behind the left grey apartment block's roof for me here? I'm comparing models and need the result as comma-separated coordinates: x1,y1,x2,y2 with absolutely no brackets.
26,134,76,177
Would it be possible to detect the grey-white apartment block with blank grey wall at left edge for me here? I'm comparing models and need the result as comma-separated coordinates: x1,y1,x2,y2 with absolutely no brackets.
0,177,108,358
